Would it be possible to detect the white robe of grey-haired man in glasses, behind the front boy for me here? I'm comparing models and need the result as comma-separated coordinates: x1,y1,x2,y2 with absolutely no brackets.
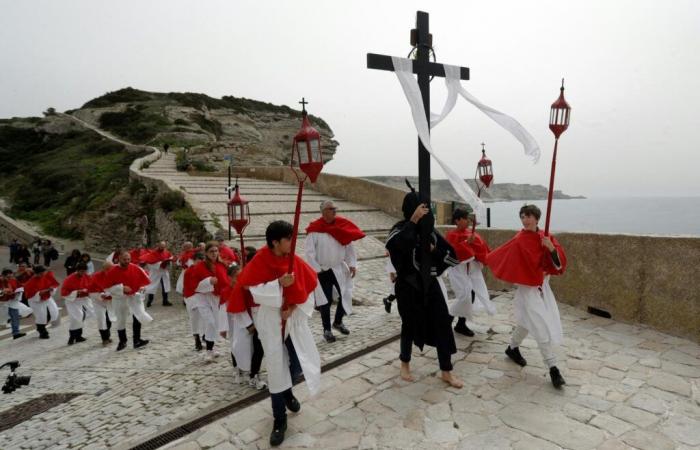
304,233,357,315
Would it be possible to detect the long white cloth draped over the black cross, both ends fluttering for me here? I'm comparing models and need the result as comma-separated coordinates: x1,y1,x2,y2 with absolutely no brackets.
391,57,540,221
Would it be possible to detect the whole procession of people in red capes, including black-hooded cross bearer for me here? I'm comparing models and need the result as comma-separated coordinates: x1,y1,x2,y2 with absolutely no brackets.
0,190,566,446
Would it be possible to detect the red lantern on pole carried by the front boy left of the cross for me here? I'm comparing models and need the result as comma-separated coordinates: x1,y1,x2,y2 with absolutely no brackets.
288,97,323,273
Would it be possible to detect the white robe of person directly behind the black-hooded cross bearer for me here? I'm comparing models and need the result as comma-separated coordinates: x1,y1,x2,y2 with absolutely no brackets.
447,258,496,319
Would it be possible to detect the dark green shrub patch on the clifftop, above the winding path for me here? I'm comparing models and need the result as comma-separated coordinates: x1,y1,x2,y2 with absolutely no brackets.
100,107,170,144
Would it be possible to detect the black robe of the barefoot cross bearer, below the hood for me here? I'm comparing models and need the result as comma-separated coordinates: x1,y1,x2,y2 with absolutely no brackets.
386,220,459,354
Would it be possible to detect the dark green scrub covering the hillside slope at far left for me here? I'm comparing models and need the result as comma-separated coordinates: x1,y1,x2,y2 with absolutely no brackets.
0,119,145,239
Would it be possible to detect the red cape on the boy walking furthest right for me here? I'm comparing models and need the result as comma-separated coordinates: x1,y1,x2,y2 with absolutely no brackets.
487,230,566,286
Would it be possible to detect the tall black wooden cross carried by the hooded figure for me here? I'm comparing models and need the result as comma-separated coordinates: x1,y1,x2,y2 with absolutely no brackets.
367,11,469,296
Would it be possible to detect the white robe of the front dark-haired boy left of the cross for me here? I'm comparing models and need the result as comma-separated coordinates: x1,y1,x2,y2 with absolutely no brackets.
250,280,321,395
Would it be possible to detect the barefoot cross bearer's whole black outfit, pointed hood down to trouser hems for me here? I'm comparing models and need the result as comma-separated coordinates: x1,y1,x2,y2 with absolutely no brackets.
386,185,459,372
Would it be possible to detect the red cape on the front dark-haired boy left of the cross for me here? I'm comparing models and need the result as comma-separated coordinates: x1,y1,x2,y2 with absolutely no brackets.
226,246,318,313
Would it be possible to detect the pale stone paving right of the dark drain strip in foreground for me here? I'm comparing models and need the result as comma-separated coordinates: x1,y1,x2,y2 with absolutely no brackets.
166,294,700,450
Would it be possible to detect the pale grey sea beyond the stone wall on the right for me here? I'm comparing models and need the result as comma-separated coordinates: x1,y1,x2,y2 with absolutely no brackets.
482,197,700,236
